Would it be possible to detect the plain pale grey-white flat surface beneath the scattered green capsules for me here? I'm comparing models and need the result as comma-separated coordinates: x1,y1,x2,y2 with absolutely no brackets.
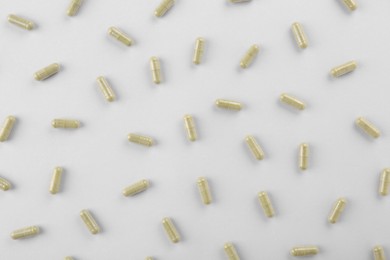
0,0,390,260
